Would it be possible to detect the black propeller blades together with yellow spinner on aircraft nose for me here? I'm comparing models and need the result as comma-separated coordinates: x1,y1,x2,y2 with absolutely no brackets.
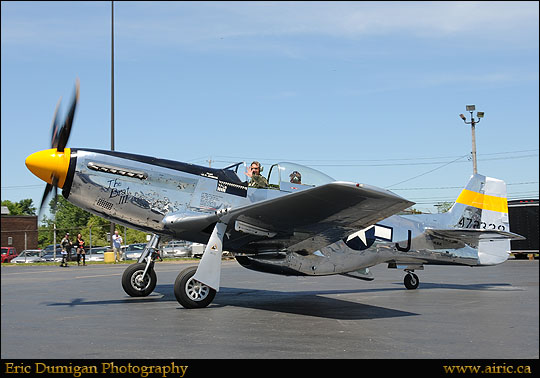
25,79,79,214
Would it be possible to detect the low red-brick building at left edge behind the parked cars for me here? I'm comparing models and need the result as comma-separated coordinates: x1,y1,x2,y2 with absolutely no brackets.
1,215,38,253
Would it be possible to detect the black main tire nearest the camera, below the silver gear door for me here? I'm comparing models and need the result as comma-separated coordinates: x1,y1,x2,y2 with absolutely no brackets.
174,266,216,308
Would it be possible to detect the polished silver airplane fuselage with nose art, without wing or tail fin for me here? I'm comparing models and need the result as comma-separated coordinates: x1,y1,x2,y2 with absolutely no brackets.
63,149,504,275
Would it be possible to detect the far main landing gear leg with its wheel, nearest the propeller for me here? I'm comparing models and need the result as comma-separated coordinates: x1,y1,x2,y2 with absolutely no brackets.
122,234,160,297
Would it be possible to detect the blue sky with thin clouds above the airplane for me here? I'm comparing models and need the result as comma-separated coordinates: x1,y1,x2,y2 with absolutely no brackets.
1,1,539,219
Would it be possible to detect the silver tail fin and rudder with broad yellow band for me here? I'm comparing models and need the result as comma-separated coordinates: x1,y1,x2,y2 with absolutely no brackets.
449,174,510,265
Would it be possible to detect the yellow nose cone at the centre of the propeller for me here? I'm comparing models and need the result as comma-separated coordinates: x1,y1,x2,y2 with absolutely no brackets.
25,148,71,188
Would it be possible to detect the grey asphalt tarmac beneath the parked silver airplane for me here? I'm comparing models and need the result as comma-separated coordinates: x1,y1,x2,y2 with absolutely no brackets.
1,260,539,360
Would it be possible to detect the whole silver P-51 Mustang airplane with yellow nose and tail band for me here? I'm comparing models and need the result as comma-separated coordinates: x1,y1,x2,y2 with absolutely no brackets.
26,82,522,308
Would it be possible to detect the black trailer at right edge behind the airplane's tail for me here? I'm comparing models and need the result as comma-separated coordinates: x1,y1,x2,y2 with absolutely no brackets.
508,199,539,259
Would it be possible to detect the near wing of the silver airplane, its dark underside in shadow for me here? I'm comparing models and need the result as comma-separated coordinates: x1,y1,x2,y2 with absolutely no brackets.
163,181,414,254
